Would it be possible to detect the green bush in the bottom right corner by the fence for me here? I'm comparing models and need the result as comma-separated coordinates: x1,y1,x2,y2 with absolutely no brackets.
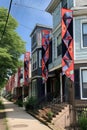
78,116,87,130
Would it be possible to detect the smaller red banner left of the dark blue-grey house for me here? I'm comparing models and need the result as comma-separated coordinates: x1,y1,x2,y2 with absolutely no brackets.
24,52,30,86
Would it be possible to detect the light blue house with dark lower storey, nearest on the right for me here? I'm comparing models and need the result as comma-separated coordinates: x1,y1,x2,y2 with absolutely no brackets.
46,0,87,105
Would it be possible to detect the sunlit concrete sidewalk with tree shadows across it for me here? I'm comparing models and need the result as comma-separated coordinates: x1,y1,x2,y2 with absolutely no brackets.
3,99,51,130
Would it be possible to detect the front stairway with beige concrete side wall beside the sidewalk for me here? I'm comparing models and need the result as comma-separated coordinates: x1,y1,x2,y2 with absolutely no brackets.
32,103,70,130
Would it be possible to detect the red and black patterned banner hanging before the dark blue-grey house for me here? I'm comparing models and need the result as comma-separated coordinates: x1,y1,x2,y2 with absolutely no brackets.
42,30,50,83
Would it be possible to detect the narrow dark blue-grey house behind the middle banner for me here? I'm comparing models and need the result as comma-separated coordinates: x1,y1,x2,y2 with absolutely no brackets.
30,24,52,100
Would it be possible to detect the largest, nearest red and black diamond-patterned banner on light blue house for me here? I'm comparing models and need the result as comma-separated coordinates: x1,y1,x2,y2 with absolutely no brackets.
62,9,74,82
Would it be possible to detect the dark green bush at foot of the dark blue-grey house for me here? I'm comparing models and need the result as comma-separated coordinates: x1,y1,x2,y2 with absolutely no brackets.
24,97,37,110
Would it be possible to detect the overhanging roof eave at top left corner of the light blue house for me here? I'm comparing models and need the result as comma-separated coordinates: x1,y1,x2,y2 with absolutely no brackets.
45,0,60,14
